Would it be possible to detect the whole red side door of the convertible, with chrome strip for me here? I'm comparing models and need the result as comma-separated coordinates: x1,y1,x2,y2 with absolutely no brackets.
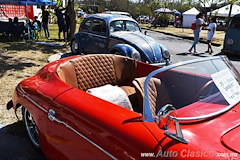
44,88,160,160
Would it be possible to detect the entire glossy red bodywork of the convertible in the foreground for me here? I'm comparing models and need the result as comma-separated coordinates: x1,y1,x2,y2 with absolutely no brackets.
9,54,240,159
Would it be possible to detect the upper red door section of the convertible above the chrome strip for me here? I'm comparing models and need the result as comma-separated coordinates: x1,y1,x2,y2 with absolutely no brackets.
52,89,163,159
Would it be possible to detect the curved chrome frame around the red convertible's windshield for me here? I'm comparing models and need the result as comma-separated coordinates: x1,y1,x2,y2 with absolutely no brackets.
143,56,237,122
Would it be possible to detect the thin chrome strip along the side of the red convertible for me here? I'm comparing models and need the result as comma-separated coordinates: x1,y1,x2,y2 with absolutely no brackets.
17,88,117,160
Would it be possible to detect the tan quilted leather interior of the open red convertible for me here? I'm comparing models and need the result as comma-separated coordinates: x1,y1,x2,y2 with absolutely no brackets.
57,54,221,115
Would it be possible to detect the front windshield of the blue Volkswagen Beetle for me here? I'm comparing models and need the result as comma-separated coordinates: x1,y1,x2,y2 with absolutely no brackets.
110,20,140,32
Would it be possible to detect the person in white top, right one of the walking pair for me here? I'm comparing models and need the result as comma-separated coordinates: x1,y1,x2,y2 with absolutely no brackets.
205,18,217,54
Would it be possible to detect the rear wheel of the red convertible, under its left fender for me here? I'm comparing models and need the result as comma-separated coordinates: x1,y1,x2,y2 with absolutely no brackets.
22,107,40,150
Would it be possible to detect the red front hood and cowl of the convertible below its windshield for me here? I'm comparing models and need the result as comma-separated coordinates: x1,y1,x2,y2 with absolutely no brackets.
146,101,240,160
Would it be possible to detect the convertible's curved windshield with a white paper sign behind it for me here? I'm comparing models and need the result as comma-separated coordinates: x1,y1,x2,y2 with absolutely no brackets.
146,57,240,117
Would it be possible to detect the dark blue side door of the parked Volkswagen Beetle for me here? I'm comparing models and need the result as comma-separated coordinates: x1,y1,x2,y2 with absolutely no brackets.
85,19,108,53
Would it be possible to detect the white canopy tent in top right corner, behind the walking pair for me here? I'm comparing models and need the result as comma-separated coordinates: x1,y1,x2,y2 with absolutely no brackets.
208,4,240,17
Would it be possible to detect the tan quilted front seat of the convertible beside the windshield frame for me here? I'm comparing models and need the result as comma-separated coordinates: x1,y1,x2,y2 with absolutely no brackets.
133,77,171,115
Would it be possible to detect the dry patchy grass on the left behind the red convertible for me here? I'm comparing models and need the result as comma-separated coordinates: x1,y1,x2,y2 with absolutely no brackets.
0,24,70,105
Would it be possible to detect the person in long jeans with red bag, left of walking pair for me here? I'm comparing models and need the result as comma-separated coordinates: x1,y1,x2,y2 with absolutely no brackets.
188,13,206,53
